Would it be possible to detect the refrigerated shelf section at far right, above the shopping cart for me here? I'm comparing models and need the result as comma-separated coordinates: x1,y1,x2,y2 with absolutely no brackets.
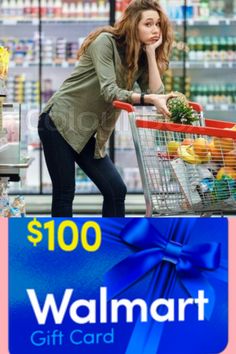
186,0,236,121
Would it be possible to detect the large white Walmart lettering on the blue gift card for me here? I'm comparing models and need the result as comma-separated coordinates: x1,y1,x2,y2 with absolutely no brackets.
26,287,209,325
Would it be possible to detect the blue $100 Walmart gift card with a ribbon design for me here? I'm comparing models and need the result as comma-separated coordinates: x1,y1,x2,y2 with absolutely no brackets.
9,218,228,354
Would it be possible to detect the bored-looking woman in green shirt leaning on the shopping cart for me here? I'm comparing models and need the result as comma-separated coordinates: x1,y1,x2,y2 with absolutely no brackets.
38,0,172,217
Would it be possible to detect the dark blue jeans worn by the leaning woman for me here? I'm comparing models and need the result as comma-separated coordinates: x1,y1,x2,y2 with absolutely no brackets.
38,113,127,217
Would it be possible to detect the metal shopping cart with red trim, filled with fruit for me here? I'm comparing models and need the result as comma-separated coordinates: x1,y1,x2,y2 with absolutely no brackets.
113,101,236,217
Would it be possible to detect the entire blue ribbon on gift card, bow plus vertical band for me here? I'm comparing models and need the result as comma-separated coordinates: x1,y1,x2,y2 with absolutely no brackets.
105,218,227,354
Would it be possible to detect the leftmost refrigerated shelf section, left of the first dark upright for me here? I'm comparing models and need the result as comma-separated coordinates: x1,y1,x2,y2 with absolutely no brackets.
0,9,40,193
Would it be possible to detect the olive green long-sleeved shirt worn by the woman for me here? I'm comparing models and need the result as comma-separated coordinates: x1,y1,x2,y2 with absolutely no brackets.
43,33,163,158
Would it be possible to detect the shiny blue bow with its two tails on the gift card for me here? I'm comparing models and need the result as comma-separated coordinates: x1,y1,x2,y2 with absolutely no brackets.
105,219,220,318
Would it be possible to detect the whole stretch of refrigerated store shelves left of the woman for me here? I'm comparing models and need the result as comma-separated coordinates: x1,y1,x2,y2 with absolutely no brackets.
0,0,110,194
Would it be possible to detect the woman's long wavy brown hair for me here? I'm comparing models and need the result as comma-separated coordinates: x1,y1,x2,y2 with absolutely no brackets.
77,0,173,89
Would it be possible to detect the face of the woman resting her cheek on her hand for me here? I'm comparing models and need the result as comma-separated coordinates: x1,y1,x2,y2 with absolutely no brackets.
138,10,161,45
